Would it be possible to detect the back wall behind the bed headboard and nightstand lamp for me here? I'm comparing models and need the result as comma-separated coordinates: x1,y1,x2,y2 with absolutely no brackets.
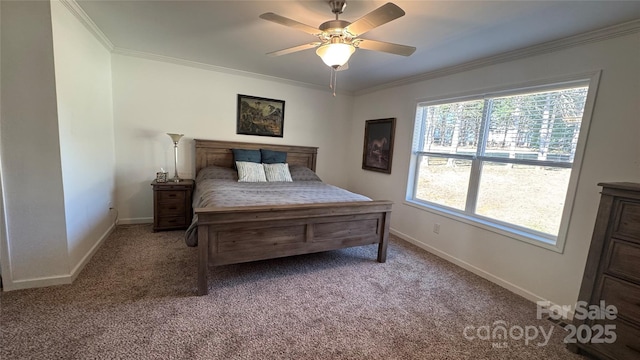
112,54,353,223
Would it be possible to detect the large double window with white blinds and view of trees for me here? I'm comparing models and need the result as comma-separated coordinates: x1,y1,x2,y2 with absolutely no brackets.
407,80,589,249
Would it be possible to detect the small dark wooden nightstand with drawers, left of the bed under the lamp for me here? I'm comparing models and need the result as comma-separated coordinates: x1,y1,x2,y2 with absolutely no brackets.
151,179,194,231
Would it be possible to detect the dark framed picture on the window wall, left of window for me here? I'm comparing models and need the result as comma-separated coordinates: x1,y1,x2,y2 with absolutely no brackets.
362,118,396,174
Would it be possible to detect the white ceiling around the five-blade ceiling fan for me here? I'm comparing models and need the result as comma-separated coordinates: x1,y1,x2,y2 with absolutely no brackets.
77,0,640,91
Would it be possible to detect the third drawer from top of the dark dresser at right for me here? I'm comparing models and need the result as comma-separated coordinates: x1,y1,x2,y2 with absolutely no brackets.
600,275,640,323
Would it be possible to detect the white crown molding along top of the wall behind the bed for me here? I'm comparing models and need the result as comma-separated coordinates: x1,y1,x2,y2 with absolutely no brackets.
111,47,353,95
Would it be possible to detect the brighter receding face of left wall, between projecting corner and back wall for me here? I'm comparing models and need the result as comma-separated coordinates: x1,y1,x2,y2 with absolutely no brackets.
51,1,115,275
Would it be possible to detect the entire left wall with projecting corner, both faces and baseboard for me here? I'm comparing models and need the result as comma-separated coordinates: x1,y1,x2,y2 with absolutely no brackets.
0,1,115,290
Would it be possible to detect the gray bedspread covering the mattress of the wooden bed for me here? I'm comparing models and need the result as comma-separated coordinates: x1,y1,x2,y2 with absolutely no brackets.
185,179,371,246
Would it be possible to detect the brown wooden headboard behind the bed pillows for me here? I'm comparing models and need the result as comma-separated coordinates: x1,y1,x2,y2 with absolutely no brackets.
195,139,318,175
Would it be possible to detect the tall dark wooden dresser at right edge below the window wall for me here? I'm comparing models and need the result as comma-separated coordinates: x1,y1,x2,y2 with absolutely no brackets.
569,183,640,360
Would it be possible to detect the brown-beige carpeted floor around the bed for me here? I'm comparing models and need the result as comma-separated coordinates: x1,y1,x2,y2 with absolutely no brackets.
0,225,582,360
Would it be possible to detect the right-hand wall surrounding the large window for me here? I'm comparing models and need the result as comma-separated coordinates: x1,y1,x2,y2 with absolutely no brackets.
347,32,640,305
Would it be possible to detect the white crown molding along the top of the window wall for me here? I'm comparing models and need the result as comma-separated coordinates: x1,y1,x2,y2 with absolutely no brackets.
353,20,640,96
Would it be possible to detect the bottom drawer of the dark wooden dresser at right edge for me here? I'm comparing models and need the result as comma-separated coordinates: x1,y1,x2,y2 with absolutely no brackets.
587,320,640,360
